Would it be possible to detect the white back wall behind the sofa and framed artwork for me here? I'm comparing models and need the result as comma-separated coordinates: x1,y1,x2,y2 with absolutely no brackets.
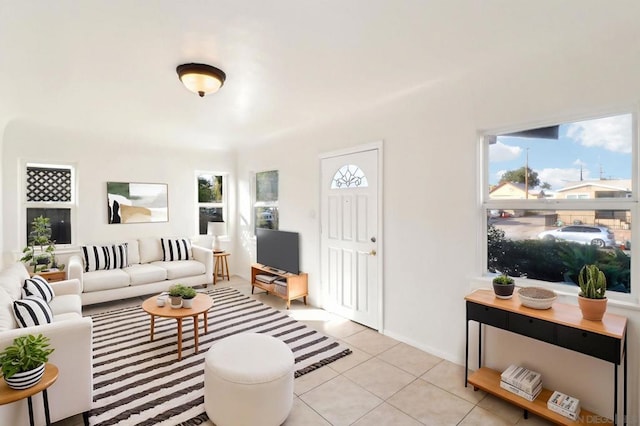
2,121,236,268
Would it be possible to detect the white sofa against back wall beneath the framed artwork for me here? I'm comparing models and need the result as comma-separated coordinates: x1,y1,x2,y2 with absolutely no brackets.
67,237,213,305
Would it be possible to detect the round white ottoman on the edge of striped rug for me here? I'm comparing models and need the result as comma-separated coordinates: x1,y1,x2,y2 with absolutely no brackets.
204,333,294,426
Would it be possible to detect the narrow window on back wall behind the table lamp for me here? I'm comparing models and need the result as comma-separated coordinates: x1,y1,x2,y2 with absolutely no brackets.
197,172,226,235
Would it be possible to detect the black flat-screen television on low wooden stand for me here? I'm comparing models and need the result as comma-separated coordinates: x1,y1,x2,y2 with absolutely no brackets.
256,228,300,275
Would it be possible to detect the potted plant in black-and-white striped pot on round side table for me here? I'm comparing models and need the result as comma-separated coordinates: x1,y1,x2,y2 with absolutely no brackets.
0,334,54,389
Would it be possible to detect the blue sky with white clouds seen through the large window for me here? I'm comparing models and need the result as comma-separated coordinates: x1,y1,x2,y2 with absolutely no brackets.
489,114,633,190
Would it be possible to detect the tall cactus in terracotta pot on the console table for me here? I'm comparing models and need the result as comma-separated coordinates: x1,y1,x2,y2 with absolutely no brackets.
578,265,607,321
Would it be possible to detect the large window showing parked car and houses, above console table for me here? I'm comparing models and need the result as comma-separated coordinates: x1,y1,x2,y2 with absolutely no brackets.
482,114,637,298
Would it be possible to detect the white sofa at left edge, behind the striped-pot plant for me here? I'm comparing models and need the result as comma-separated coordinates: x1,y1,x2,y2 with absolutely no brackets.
0,263,93,425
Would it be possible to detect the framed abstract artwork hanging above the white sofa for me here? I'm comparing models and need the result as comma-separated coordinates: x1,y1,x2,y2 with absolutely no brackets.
107,182,169,223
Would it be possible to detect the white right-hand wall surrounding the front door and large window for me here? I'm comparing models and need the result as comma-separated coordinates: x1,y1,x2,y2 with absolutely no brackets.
238,45,640,424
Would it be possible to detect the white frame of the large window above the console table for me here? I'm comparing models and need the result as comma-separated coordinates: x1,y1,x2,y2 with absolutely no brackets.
476,109,640,306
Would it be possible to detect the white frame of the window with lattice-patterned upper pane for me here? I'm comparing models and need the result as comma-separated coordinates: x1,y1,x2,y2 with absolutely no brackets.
19,160,78,250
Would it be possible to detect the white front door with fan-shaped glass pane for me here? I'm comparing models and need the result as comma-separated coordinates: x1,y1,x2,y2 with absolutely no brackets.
320,147,382,330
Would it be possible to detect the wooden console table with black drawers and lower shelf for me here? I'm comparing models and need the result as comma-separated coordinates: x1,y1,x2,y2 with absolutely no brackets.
464,289,627,424
